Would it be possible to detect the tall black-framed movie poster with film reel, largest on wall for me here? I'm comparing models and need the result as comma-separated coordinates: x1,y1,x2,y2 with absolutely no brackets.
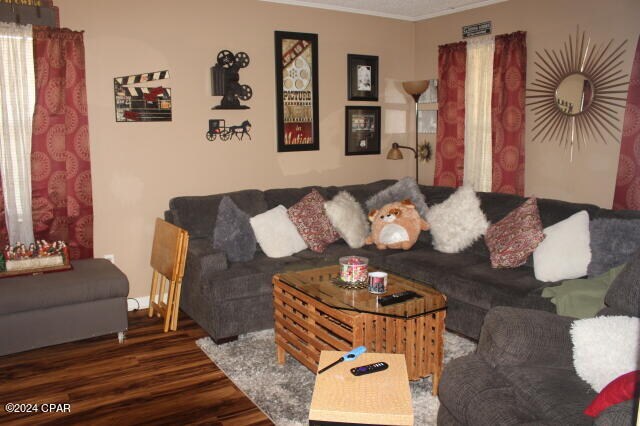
275,31,320,152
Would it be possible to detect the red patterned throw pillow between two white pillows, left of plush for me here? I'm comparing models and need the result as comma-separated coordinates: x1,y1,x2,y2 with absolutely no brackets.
287,189,340,253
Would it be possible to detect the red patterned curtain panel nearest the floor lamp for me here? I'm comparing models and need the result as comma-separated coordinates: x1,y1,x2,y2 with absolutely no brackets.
433,42,467,187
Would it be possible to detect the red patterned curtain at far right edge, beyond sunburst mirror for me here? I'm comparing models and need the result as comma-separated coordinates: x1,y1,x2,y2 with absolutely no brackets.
613,37,640,210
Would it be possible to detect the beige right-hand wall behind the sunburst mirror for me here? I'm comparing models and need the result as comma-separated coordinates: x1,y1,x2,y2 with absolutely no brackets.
415,0,640,208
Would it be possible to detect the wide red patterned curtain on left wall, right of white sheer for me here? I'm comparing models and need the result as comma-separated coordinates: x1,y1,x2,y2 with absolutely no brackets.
31,27,93,259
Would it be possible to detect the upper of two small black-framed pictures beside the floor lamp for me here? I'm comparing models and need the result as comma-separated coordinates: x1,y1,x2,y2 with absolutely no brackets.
347,54,378,101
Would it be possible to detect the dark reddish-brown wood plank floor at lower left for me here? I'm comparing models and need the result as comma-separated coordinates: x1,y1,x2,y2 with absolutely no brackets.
0,311,273,426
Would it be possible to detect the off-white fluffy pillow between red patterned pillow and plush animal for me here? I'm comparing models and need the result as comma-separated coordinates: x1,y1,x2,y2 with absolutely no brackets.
324,191,369,248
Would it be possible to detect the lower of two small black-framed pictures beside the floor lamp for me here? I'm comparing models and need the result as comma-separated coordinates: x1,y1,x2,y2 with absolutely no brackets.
344,106,381,155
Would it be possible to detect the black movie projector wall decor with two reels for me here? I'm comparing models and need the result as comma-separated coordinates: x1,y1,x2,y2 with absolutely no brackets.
211,50,253,109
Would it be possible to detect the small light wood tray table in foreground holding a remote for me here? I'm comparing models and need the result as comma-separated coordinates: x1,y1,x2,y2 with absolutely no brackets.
309,351,413,426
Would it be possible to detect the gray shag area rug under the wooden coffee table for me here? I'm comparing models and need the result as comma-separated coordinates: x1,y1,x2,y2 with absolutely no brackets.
196,330,476,426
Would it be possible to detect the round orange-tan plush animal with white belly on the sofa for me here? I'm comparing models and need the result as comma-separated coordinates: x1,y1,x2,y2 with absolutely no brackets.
365,200,429,250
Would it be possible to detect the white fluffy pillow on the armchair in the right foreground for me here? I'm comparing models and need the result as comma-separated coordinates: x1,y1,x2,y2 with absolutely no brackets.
571,316,640,392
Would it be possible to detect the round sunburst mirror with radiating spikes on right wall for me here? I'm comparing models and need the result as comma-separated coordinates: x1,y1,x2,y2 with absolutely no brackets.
527,28,629,154
